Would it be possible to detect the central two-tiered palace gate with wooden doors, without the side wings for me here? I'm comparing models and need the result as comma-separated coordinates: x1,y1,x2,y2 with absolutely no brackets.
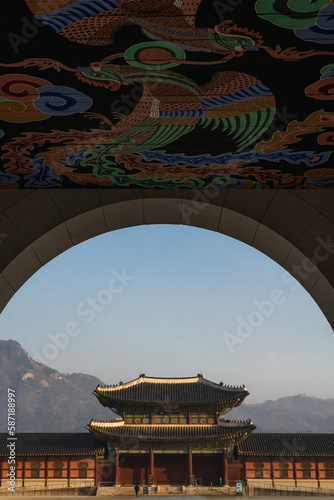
87,374,255,486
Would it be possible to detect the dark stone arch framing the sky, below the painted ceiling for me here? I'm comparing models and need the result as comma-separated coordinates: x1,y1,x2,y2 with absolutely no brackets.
0,188,334,329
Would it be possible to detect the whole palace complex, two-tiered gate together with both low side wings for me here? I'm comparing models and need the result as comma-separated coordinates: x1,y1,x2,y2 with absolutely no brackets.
0,374,334,495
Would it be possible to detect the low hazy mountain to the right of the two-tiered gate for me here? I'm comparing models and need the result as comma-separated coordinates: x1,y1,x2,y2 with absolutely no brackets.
226,394,334,433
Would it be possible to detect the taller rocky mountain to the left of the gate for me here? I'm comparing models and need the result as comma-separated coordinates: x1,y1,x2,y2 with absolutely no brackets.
0,340,115,432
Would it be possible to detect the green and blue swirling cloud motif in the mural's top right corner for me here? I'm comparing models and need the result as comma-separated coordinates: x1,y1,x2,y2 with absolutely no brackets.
255,0,334,44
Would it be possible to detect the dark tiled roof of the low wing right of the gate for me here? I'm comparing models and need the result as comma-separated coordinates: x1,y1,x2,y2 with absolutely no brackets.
237,433,334,457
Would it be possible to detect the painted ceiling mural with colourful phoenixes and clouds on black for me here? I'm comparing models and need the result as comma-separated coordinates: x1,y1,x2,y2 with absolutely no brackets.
0,0,334,189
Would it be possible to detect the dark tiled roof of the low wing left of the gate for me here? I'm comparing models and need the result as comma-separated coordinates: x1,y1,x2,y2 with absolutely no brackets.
0,432,104,456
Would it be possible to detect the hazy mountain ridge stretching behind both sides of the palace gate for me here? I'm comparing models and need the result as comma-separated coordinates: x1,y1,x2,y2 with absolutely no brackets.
0,340,334,433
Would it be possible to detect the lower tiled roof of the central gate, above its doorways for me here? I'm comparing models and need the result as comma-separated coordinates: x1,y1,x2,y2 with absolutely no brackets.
87,421,255,442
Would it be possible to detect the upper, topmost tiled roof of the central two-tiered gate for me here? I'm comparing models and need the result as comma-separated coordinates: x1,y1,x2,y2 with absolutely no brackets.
94,375,248,406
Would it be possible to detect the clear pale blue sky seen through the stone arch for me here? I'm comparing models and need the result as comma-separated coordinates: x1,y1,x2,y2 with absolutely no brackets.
0,225,334,403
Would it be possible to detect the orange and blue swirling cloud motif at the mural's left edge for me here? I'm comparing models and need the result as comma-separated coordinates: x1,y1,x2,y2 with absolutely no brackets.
0,74,92,123
